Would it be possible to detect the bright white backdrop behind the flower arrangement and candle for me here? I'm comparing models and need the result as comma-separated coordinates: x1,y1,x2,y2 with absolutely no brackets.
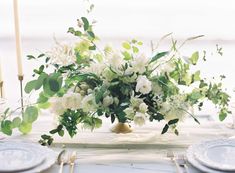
0,0,235,117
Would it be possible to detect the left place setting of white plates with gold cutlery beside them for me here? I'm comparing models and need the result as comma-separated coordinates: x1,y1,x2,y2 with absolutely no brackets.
0,140,77,173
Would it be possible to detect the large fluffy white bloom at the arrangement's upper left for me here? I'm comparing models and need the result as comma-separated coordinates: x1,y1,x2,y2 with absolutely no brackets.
48,44,76,66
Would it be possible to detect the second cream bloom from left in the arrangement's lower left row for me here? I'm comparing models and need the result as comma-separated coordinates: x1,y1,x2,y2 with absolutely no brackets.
62,92,82,110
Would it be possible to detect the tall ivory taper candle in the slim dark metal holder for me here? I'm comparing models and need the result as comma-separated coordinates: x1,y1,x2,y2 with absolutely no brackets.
13,0,23,76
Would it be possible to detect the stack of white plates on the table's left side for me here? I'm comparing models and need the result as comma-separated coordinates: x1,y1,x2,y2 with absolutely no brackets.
0,141,57,173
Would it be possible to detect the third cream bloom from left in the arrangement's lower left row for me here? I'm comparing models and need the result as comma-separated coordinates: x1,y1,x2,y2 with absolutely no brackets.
82,94,97,112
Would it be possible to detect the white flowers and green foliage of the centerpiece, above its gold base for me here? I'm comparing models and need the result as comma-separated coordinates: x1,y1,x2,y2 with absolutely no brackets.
1,13,230,144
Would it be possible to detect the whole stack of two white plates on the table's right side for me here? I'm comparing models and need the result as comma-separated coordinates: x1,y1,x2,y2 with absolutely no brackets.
186,139,235,173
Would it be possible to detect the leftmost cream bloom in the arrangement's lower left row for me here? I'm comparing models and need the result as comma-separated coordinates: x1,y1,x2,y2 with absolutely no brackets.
50,97,66,115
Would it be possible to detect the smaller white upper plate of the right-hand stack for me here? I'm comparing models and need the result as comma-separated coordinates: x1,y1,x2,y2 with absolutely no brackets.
194,139,235,171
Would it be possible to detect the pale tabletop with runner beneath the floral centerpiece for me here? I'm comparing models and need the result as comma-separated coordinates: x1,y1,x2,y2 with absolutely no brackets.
3,114,235,173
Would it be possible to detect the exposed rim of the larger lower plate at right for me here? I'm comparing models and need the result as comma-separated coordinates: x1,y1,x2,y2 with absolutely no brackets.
186,139,234,173
